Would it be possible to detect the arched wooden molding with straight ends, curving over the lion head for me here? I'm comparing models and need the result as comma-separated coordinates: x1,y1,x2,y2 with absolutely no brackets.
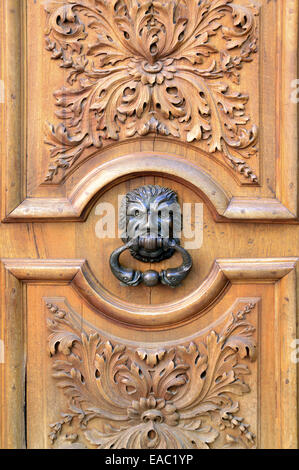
1,152,294,222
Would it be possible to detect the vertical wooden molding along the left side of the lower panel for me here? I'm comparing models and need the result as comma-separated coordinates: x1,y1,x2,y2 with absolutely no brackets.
0,266,26,449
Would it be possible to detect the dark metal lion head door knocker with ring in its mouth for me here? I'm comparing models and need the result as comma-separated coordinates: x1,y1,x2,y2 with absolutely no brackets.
110,185,192,287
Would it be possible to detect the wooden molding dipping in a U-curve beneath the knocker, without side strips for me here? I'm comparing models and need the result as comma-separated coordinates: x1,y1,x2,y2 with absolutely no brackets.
2,258,297,329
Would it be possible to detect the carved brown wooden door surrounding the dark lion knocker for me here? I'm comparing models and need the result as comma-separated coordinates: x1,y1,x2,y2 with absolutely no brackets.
0,0,299,449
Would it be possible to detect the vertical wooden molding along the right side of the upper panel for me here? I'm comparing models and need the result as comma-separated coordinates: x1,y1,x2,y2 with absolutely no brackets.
273,0,299,215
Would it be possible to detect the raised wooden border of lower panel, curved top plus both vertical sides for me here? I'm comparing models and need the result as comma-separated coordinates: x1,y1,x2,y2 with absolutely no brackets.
0,258,299,448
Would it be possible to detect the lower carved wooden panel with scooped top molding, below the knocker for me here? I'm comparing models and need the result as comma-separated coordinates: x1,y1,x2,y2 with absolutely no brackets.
4,258,297,448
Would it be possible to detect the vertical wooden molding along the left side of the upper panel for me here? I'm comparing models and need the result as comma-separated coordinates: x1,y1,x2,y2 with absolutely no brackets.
1,0,26,218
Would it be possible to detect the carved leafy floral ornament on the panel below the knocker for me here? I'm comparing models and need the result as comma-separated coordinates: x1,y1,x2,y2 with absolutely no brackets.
47,303,256,449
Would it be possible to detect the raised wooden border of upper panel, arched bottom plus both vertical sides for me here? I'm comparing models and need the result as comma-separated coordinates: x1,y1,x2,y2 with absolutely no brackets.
1,0,299,223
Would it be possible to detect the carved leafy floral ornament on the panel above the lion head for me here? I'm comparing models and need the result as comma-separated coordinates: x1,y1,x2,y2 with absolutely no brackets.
45,0,258,183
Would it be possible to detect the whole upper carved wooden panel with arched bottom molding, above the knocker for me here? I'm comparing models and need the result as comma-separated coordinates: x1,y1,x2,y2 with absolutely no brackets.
2,0,297,222
